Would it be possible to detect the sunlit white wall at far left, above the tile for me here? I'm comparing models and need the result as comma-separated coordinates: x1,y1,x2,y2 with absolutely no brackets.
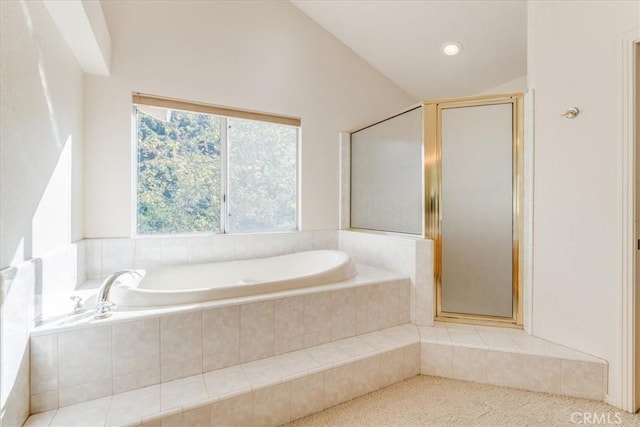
0,1,83,268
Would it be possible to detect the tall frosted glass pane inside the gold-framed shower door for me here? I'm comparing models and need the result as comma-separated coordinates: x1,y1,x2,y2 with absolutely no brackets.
441,104,513,317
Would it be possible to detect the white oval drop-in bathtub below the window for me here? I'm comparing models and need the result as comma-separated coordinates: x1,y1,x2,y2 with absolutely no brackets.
109,250,357,307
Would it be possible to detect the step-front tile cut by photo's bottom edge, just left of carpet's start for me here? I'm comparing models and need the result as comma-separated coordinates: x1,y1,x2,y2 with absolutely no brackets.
253,382,291,426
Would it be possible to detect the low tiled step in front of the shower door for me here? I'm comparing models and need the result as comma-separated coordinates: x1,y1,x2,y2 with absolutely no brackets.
419,323,607,400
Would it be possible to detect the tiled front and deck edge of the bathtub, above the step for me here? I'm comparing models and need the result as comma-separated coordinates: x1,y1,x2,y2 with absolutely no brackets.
30,266,410,413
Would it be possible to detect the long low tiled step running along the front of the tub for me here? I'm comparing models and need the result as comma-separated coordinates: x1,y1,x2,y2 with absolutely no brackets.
25,324,420,426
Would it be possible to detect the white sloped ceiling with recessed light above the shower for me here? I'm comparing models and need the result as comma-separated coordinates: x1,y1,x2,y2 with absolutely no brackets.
291,0,527,100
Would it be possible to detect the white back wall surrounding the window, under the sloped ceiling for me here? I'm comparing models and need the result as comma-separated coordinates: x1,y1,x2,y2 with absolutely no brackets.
85,1,415,237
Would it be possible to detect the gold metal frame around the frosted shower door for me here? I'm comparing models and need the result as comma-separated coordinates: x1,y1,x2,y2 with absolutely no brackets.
423,93,524,328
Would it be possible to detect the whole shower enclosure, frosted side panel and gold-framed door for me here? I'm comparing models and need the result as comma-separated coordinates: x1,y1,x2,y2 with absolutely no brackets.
350,93,523,326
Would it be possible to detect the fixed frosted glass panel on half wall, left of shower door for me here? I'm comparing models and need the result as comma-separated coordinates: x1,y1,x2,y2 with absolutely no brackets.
351,107,423,234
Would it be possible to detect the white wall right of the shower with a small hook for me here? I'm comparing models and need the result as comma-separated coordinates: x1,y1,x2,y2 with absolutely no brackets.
528,1,640,405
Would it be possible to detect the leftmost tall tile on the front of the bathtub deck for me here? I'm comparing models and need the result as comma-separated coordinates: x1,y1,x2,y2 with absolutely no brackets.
30,334,58,394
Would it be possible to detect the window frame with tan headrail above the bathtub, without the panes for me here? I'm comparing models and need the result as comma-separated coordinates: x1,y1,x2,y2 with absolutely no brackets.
131,92,302,238
